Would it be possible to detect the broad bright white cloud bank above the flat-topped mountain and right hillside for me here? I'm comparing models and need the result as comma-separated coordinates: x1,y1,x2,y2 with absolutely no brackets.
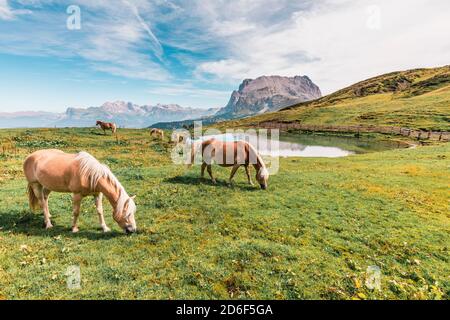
197,0,450,93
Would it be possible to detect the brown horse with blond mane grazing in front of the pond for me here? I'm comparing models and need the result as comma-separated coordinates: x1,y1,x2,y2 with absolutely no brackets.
191,139,269,190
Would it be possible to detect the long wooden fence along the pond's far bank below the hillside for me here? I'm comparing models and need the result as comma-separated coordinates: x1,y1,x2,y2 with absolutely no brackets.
258,121,450,141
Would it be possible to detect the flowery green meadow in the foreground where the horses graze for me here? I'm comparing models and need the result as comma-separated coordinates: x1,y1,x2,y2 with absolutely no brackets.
0,128,450,299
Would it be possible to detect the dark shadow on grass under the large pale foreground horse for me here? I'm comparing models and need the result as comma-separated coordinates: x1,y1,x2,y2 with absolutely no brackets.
0,211,126,240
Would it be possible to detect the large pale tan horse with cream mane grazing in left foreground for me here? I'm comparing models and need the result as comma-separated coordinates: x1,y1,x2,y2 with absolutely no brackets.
23,149,136,233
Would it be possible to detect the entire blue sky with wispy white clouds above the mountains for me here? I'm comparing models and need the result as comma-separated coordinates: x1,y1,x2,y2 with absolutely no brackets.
0,0,450,112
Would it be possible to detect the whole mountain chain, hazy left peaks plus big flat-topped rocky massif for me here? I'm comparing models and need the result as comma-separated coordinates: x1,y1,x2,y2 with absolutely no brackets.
0,76,322,128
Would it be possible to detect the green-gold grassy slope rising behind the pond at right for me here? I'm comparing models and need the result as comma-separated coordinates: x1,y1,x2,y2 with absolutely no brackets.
224,66,450,131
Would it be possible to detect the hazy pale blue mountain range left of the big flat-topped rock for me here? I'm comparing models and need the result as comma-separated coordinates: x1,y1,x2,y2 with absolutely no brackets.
0,101,218,128
